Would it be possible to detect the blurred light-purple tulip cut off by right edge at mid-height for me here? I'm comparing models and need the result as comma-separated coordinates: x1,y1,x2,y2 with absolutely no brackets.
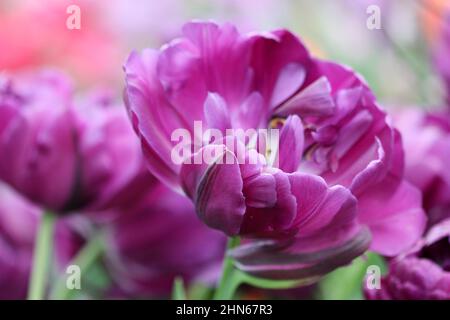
396,110,450,225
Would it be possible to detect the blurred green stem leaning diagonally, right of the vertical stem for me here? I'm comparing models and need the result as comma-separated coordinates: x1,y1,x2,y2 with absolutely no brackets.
51,232,104,300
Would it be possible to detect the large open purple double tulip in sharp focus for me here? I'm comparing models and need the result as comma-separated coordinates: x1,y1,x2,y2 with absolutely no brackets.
125,22,425,279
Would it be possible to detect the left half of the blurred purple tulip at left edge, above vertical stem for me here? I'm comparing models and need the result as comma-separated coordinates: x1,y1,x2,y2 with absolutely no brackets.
0,73,77,211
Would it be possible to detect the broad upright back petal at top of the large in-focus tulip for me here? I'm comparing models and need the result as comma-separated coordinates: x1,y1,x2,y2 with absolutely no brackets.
181,22,255,108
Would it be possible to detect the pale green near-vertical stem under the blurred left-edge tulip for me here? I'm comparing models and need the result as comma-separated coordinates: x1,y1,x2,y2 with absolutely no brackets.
28,211,56,300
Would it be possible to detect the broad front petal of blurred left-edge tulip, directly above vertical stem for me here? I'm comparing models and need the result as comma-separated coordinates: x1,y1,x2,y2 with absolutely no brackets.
0,107,76,212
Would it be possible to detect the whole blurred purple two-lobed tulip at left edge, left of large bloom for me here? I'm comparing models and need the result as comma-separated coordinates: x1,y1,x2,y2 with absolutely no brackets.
0,72,151,213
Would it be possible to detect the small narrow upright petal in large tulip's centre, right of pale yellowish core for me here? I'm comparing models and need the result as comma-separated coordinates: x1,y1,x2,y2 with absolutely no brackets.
278,115,304,173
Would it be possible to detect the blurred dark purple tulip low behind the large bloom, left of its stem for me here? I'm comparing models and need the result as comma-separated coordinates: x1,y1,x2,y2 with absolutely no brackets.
107,183,226,297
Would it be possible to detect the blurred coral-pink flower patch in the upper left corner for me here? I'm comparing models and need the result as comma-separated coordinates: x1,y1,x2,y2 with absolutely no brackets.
0,0,124,85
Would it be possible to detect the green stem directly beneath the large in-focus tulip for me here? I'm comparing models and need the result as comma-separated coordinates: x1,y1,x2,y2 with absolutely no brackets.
214,237,240,300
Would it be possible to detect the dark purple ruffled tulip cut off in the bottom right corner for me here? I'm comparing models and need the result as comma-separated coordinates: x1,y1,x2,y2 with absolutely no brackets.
364,219,450,300
